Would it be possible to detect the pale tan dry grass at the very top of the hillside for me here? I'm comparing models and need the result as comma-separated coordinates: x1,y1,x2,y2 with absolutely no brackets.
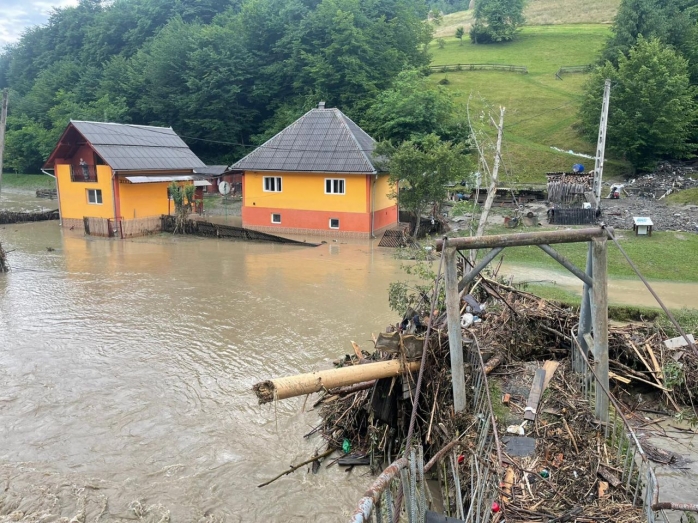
435,0,620,37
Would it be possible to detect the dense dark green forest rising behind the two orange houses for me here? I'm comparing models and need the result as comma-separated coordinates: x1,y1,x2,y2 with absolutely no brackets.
0,0,431,173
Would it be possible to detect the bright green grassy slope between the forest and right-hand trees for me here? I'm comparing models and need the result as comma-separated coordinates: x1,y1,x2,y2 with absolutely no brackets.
430,24,628,183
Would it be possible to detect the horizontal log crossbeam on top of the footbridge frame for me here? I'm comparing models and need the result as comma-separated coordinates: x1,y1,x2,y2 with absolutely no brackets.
436,227,613,251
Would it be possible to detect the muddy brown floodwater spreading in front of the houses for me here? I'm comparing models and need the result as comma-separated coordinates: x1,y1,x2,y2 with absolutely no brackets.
0,192,695,522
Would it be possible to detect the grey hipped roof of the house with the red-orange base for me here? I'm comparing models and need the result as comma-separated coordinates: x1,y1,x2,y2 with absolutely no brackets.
230,109,377,174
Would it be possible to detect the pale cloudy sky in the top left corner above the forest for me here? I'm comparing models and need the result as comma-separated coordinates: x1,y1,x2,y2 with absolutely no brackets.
0,0,78,48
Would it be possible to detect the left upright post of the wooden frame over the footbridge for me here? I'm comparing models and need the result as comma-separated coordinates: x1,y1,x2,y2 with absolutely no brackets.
443,246,466,412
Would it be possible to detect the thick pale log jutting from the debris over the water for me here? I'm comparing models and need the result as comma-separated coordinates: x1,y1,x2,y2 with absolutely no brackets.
252,360,420,404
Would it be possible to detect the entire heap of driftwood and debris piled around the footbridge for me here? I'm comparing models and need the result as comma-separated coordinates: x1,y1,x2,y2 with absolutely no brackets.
255,275,698,523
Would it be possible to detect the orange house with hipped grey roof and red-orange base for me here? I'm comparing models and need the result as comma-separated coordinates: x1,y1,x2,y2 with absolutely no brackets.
230,102,398,237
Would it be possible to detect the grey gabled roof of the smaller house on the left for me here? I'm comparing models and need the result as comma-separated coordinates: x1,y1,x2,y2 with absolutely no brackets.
71,121,205,171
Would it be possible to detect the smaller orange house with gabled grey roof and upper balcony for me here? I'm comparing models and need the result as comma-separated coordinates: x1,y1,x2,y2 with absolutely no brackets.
44,121,208,237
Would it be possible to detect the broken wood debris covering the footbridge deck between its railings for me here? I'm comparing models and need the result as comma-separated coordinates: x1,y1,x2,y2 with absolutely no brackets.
486,363,643,522
